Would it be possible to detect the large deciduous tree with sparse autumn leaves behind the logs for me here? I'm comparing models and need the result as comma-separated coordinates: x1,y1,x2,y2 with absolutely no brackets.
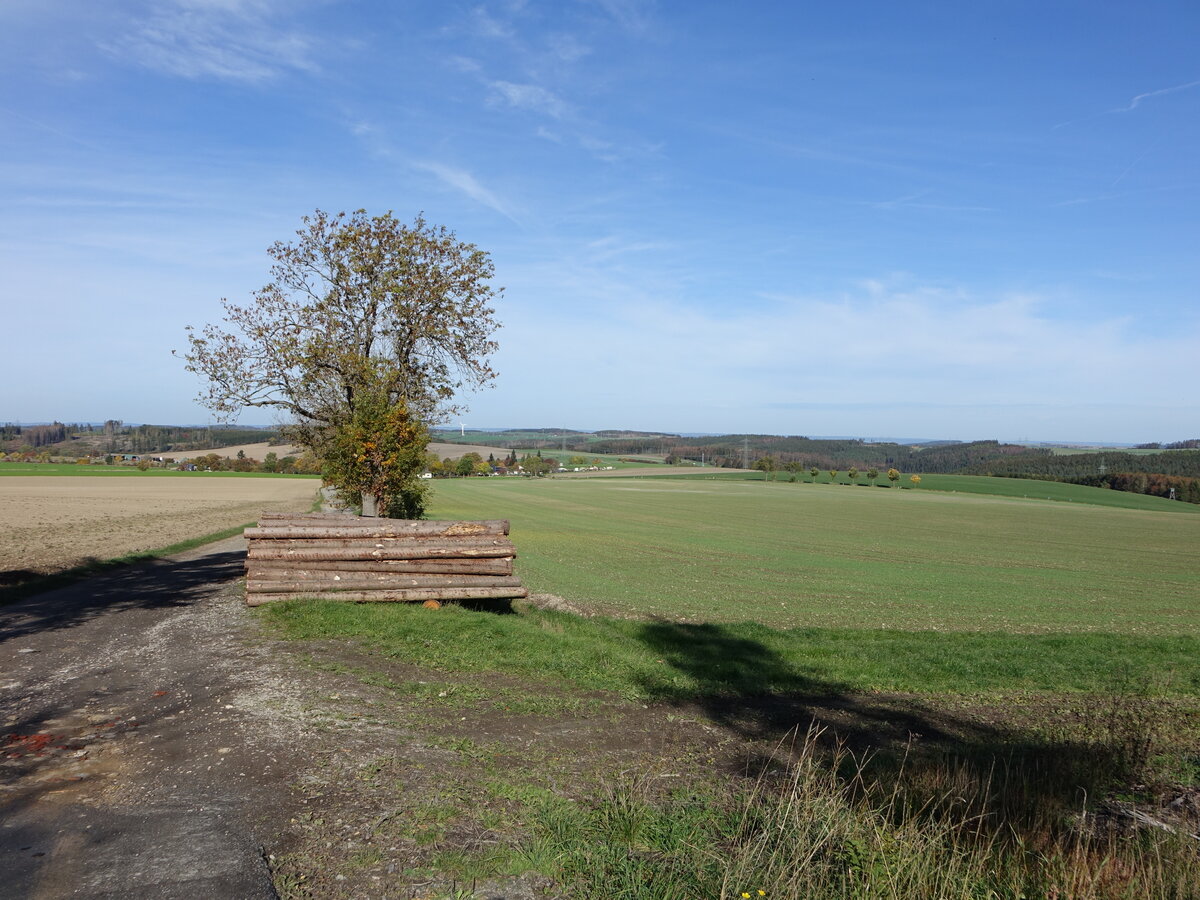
182,210,503,517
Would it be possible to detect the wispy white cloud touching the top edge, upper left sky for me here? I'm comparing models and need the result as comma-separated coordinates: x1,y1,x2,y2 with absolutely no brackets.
101,0,317,83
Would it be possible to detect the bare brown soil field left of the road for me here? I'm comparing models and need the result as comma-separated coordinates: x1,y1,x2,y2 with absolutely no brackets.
0,475,320,584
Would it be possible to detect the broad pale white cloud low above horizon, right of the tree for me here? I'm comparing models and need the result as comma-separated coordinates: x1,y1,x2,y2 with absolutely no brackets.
480,260,1200,438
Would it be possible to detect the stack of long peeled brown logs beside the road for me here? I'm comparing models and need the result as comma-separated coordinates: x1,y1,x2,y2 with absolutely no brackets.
245,514,528,606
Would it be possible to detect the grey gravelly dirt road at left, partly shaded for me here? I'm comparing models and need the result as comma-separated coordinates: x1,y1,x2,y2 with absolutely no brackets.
0,538,305,899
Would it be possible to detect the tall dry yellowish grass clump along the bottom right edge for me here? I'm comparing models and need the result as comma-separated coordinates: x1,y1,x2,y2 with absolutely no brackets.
511,734,1196,900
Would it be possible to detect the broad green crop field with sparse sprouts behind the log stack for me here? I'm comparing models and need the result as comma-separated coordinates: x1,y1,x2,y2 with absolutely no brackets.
431,479,1200,636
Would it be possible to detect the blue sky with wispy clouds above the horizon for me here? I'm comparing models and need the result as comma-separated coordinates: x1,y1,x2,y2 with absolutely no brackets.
0,0,1200,442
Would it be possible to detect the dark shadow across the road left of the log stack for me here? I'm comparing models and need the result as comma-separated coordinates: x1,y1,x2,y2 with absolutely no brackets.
0,550,246,642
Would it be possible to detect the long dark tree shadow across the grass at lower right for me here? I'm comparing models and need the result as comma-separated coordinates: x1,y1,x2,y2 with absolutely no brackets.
638,620,1180,840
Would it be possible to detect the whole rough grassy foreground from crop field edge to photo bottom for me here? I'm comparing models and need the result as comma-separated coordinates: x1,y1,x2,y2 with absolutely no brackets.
267,602,1200,900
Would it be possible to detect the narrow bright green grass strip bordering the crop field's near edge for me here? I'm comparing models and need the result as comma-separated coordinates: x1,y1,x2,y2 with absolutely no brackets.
263,602,1200,701
